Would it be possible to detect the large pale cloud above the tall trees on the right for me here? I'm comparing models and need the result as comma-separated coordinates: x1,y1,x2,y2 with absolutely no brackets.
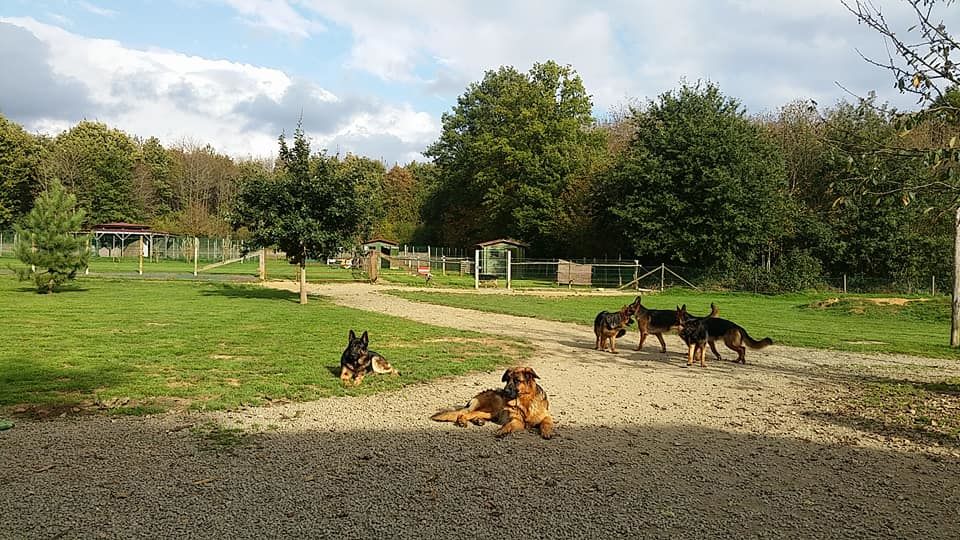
282,0,948,111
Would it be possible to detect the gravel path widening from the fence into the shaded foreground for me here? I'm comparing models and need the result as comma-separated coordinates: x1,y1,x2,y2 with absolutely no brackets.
0,284,960,539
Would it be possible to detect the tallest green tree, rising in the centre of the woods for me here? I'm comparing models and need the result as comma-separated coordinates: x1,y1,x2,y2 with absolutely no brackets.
425,61,604,254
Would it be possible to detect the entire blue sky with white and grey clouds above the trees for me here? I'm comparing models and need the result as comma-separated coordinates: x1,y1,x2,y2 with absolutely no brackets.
0,0,960,164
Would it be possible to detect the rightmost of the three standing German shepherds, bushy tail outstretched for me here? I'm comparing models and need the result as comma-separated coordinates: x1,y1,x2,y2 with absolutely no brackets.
676,305,773,367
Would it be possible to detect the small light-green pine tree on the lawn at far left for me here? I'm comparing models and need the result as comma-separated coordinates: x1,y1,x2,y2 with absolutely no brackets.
15,181,90,293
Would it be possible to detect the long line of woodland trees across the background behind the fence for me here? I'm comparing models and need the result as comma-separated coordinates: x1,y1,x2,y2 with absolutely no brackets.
0,61,960,290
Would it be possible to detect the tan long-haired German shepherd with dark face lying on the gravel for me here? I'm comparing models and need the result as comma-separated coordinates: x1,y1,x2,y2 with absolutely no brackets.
430,367,553,439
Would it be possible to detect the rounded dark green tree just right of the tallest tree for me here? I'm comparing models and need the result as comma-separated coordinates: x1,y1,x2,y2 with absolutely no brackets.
595,83,786,268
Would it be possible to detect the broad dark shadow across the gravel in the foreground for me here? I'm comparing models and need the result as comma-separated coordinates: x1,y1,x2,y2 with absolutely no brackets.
0,424,960,539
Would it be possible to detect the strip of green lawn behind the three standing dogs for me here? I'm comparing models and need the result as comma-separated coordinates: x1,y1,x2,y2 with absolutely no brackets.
391,289,960,359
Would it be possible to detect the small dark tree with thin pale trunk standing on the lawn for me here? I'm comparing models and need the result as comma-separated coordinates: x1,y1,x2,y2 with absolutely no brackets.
231,125,362,304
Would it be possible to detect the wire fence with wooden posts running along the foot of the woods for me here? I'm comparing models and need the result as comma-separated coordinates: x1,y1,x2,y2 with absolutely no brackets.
0,230,953,296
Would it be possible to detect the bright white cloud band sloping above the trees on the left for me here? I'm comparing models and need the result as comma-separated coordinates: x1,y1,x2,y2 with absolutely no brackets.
0,18,439,161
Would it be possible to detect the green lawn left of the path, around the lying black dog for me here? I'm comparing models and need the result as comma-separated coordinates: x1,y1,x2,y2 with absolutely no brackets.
0,275,530,415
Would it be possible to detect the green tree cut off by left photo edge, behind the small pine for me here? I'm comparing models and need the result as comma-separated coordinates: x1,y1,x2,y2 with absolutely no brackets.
0,116,43,230
